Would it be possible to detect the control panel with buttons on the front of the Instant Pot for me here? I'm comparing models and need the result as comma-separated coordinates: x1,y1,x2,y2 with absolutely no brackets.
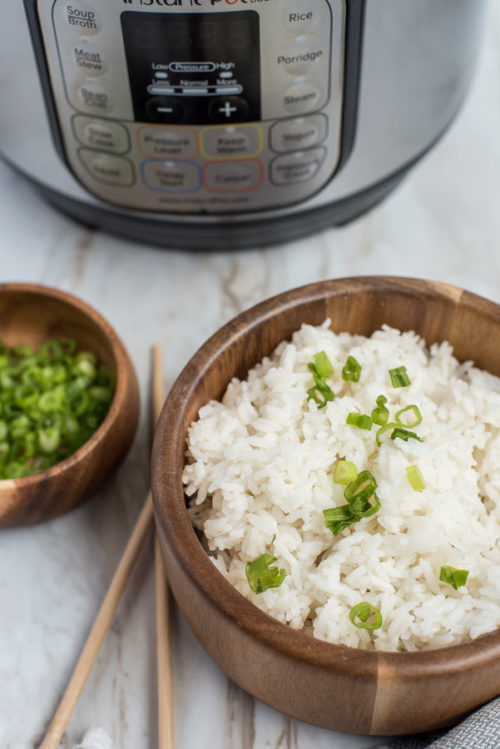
38,0,345,214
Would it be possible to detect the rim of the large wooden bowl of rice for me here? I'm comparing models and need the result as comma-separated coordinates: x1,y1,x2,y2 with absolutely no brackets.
152,275,500,681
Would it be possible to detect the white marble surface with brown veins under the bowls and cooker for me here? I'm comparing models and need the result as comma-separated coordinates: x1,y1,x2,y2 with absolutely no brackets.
0,3,500,749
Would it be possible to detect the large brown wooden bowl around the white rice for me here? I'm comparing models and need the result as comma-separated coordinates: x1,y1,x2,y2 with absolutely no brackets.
153,277,500,734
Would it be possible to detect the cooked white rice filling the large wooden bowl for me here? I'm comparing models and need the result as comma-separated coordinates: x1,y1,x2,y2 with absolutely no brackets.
183,320,500,651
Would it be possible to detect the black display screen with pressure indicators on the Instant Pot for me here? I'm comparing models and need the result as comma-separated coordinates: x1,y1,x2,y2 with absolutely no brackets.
121,10,261,125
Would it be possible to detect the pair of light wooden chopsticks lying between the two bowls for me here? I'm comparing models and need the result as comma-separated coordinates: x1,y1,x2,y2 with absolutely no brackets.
39,344,174,749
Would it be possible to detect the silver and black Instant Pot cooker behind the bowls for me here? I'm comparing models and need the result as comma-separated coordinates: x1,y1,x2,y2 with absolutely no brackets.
0,0,486,249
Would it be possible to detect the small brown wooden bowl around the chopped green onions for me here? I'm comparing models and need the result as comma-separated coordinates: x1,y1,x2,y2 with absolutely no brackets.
0,284,139,528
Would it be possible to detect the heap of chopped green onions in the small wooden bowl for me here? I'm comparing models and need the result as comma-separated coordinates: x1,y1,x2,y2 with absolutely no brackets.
0,338,115,479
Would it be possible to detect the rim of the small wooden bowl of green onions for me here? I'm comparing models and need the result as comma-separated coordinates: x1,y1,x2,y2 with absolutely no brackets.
0,282,135,486
